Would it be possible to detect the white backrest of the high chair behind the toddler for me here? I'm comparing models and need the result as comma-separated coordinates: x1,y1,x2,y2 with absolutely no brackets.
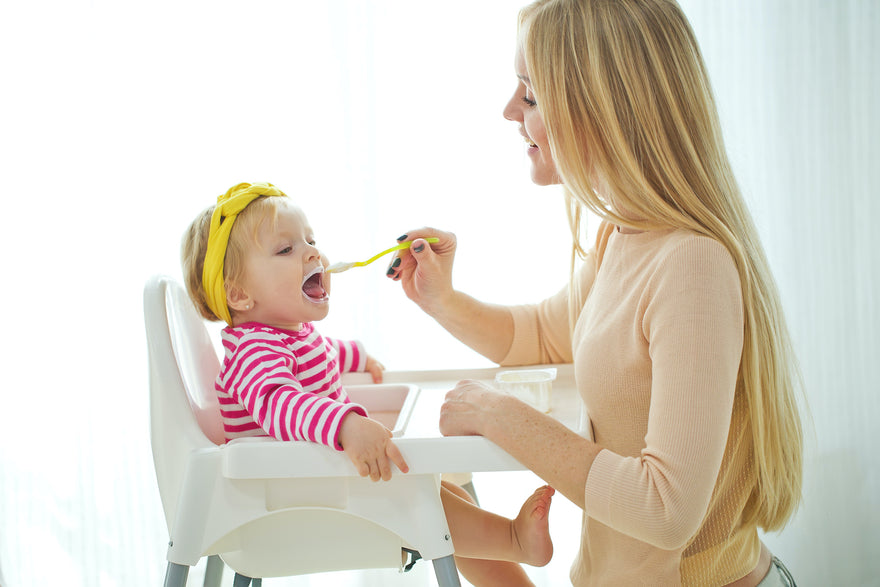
144,276,224,530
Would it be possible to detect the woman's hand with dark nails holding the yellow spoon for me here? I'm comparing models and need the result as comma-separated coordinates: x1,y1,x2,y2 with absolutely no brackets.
387,228,456,315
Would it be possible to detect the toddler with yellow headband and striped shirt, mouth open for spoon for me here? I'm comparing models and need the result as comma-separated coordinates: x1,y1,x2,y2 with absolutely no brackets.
181,183,554,585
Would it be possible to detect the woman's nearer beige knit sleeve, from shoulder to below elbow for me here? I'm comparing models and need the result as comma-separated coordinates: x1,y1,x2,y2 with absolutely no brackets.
585,237,743,550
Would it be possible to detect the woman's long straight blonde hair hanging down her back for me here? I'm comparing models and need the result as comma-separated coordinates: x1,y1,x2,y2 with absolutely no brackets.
520,0,803,531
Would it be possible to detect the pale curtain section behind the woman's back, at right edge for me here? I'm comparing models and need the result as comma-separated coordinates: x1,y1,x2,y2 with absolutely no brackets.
681,0,880,585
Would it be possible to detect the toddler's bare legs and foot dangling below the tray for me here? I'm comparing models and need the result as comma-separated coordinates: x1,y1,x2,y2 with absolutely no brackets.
441,483,555,586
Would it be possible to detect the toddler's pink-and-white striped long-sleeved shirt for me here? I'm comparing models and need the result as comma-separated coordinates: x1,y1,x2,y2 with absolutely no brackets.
215,322,367,450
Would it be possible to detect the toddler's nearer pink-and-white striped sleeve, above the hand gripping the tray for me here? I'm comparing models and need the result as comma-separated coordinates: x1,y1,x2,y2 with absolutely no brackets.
224,340,366,450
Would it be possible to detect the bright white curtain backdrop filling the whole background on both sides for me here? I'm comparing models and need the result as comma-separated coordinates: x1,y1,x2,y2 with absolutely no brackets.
0,0,880,587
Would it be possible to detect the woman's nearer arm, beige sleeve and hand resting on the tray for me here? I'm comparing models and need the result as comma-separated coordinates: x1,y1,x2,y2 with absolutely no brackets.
440,239,744,550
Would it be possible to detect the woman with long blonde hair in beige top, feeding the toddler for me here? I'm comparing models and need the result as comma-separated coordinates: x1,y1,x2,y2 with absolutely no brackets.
389,0,802,587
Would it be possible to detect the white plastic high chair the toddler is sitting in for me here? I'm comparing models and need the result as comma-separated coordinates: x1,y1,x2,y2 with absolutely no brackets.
144,276,460,587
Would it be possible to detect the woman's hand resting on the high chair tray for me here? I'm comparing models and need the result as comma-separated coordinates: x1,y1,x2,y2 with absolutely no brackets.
440,379,511,436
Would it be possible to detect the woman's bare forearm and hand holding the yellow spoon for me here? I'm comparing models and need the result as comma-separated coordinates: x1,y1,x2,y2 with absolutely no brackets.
388,228,513,363
